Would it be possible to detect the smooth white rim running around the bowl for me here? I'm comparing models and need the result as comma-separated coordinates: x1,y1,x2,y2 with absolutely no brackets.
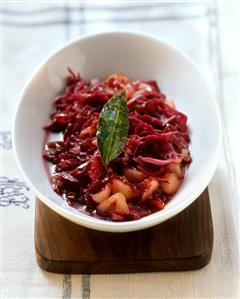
12,30,222,232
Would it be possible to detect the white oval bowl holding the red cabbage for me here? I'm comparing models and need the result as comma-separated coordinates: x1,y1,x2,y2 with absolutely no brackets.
14,32,221,232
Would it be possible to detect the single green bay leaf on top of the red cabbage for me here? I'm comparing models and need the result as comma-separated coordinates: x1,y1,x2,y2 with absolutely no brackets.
97,92,129,166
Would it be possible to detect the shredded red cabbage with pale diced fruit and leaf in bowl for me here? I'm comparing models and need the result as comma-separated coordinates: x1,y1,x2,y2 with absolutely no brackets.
43,69,192,221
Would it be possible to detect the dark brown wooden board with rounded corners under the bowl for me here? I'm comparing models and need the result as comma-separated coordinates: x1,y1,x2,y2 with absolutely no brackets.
35,189,213,273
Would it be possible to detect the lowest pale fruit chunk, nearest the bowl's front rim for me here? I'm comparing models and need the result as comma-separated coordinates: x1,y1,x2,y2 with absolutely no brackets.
97,192,129,214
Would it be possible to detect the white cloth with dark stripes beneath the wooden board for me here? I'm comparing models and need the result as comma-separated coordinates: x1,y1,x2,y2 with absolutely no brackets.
0,1,240,299
